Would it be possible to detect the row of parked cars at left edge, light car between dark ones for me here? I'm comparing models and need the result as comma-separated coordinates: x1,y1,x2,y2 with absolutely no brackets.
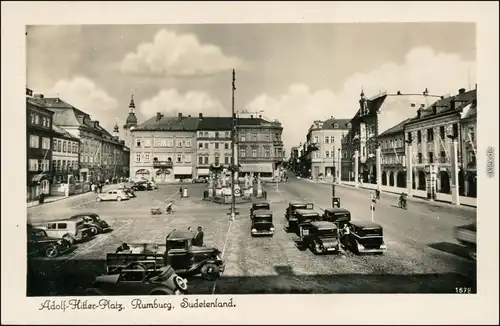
27,213,112,258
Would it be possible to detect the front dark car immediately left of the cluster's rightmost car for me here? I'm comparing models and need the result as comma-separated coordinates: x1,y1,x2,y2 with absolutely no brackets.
299,221,340,254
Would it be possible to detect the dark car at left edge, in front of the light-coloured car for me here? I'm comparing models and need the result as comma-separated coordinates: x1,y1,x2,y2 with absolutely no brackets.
27,224,71,258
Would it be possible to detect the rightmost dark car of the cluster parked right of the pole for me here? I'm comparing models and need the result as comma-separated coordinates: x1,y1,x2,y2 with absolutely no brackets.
342,221,387,255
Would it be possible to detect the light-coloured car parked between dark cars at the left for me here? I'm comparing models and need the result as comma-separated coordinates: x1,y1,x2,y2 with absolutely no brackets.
34,219,93,245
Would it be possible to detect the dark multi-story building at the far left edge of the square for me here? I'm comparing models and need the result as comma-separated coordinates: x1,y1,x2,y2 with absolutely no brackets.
26,88,54,200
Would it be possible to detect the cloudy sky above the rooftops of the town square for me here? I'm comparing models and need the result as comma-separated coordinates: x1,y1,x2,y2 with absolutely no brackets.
27,23,476,152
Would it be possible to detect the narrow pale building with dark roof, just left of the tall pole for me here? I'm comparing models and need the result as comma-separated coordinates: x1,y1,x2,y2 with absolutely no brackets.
196,113,233,177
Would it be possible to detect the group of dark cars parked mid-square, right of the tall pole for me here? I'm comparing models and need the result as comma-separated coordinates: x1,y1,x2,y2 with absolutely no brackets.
250,202,387,254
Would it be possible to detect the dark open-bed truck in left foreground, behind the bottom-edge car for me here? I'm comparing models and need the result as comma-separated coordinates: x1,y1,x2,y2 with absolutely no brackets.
106,230,225,281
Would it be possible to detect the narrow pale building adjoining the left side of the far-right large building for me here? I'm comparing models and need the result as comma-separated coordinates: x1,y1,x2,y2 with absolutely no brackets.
377,119,410,188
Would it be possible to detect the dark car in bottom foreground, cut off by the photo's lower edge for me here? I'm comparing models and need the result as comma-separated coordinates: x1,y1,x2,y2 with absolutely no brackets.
85,261,187,296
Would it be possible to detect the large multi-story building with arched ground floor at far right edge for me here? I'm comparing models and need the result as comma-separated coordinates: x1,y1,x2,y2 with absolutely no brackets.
405,88,477,195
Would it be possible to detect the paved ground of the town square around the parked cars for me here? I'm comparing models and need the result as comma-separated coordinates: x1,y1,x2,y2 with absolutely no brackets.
28,178,476,295
